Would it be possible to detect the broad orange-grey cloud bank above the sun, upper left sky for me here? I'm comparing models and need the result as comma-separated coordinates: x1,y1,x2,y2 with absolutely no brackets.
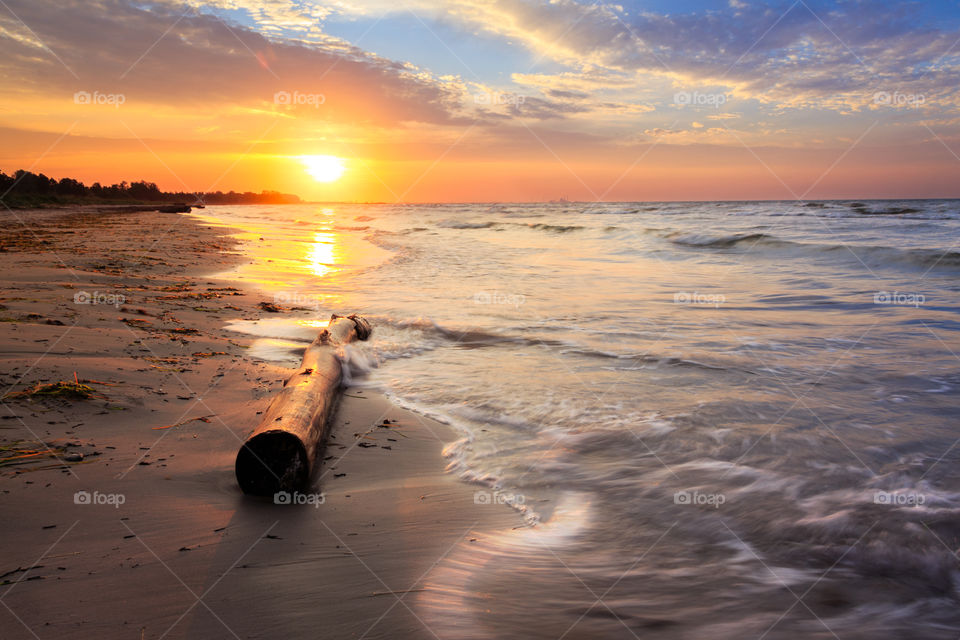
0,0,461,125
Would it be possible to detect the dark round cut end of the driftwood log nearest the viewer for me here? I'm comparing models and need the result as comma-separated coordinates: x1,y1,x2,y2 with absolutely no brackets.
236,430,310,496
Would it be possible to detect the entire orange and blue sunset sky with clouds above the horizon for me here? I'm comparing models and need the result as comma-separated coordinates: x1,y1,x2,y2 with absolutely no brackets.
0,0,960,202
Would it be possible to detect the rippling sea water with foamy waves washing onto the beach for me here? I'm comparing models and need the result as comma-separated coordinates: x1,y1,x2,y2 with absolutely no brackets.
193,201,960,638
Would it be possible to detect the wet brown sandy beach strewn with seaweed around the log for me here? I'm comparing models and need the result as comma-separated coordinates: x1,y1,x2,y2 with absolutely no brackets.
0,209,521,639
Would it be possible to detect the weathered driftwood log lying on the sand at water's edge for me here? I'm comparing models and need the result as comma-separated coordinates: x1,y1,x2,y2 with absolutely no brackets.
236,315,370,495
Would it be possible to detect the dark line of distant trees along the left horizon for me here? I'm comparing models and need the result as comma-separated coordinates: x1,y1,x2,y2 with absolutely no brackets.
0,169,302,205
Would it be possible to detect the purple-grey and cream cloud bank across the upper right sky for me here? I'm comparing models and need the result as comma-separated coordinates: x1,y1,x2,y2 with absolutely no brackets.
424,0,960,109
